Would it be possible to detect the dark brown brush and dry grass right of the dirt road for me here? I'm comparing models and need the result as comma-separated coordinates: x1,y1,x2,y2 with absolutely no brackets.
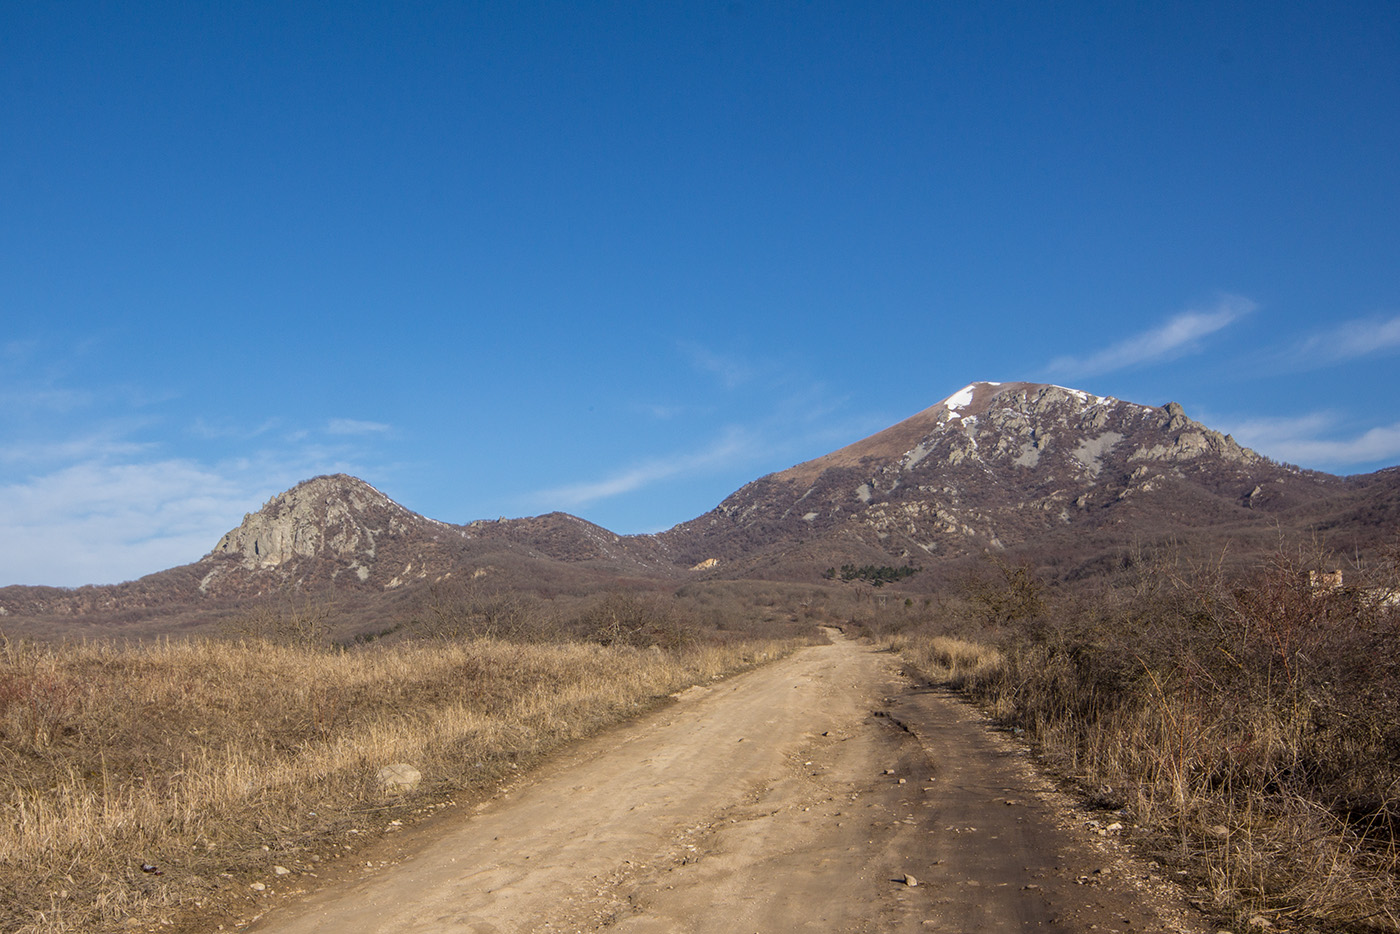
883,559,1400,931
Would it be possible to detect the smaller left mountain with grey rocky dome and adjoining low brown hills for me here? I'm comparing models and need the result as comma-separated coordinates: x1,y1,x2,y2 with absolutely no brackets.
0,473,659,619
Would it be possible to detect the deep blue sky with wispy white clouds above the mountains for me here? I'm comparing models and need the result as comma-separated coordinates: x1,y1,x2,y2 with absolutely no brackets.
0,1,1400,585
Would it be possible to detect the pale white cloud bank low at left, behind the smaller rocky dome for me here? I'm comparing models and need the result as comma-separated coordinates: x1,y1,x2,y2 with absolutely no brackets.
0,403,386,587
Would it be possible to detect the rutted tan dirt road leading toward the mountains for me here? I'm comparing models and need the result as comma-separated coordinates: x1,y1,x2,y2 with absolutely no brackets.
240,634,1196,934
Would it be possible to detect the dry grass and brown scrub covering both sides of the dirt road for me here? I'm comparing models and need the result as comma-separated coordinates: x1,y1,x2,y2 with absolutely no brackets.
13,543,1400,934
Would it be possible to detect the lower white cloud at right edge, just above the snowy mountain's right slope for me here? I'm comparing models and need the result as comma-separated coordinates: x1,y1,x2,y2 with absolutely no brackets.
1219,412,1400,471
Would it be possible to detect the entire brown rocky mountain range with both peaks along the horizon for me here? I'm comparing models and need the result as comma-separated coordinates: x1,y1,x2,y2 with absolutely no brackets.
0,382,1400,619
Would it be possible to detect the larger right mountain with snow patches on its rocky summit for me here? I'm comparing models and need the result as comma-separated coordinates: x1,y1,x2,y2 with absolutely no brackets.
659,382,1393,577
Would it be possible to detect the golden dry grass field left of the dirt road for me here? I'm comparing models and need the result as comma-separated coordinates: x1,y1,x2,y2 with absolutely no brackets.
0,639,788,934
